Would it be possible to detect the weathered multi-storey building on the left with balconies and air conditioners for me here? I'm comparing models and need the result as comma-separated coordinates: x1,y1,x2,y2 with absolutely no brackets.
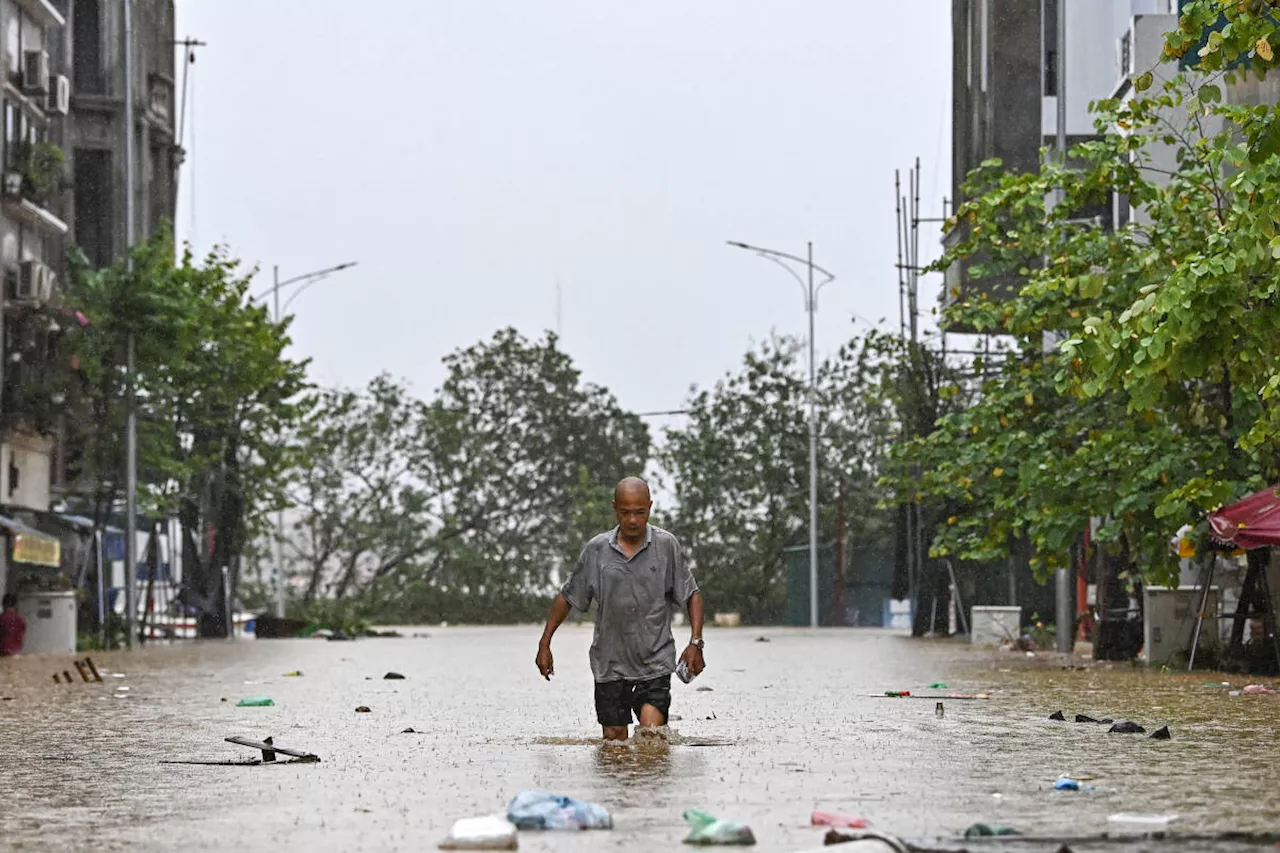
0,0,178,511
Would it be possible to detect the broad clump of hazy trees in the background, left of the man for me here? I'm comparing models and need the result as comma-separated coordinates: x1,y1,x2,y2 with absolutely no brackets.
291,329,649,621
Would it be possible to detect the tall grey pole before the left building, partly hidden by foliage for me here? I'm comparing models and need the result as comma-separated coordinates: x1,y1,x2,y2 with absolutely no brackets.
120,0,138,649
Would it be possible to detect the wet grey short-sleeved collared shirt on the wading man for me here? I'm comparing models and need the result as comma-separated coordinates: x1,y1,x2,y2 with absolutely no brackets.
561,524,698,681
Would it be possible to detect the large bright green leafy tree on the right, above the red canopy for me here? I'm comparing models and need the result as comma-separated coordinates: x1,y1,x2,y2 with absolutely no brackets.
904,9,1280,580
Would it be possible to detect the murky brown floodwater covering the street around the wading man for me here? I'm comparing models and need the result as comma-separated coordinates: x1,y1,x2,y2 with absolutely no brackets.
0,625,1280,853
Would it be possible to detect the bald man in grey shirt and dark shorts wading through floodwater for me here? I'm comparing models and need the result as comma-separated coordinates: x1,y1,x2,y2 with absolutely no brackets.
538,476,707,740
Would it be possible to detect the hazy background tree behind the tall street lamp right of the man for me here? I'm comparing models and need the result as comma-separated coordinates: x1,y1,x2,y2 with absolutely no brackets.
660,336,893,622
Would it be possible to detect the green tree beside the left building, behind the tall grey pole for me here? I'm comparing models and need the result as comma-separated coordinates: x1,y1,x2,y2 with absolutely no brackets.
67,233,307,635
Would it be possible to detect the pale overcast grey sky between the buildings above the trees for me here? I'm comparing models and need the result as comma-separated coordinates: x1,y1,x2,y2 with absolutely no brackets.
178,0,950,429
